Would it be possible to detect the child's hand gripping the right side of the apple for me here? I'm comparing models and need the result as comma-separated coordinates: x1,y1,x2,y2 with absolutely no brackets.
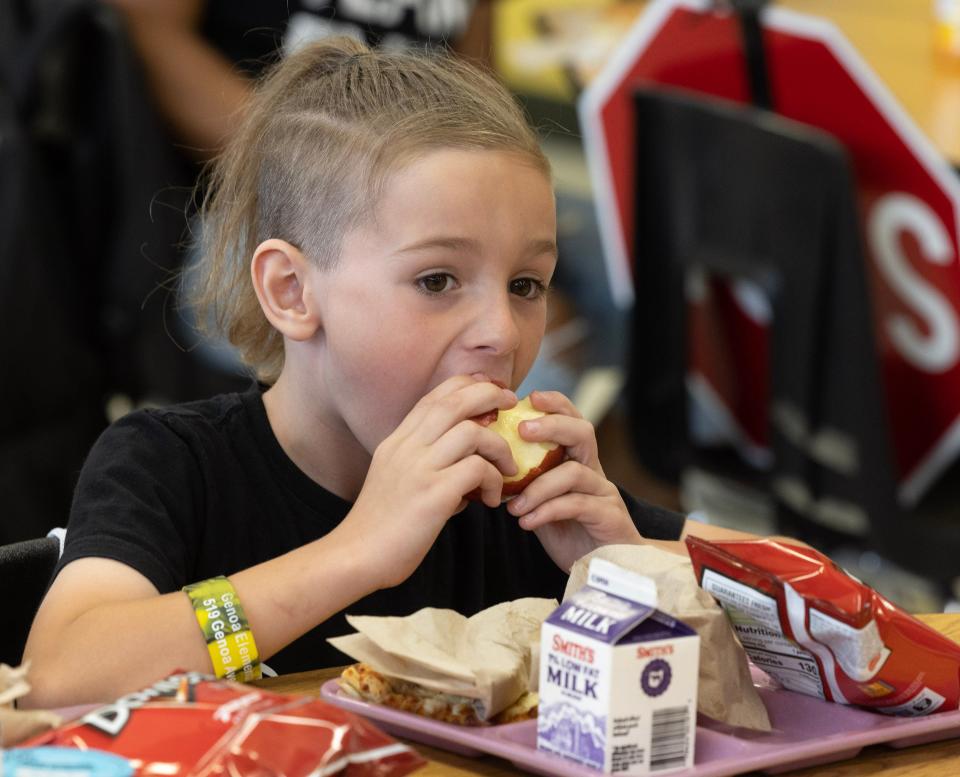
507,391,642,571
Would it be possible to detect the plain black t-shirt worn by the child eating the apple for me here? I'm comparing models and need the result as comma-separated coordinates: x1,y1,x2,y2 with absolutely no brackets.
58,386,683,672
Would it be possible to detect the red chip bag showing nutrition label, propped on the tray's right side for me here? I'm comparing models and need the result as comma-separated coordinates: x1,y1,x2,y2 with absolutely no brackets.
687,537,960,715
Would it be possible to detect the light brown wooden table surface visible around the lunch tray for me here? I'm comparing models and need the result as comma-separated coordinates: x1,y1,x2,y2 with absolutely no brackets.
257,614,960,777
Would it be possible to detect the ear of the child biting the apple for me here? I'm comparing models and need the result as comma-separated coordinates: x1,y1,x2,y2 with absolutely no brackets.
250,238,320,340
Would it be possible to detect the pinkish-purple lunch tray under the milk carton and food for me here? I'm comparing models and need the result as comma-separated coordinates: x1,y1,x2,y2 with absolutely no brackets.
320,669,960,777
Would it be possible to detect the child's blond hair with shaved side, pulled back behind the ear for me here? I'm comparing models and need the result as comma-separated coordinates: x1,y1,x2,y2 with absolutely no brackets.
189,38,550,383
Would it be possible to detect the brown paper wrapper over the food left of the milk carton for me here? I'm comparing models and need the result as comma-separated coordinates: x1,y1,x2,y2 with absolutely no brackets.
329,598,557,720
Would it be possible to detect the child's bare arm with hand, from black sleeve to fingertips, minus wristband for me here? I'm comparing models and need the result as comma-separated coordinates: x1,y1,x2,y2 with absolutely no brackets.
25,376,516,706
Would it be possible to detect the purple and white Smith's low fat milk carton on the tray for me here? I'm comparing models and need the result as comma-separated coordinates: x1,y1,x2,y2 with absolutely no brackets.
537,559,700,775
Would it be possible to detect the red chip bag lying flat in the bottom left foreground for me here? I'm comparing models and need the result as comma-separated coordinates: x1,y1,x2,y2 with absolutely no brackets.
24,672,426,777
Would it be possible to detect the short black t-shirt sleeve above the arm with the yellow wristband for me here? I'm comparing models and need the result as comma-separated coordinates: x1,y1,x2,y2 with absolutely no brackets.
56,411,202,593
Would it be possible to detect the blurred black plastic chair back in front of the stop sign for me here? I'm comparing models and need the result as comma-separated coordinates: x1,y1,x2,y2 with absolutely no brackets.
627,89,900,550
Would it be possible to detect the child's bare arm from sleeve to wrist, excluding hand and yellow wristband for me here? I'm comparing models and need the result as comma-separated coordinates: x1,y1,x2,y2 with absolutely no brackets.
24,520,382,707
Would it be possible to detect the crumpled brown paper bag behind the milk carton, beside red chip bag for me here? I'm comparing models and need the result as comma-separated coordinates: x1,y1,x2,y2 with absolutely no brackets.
564,545,770,731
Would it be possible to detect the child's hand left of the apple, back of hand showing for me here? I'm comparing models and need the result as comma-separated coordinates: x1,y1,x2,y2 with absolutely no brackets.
337,375,517,587
